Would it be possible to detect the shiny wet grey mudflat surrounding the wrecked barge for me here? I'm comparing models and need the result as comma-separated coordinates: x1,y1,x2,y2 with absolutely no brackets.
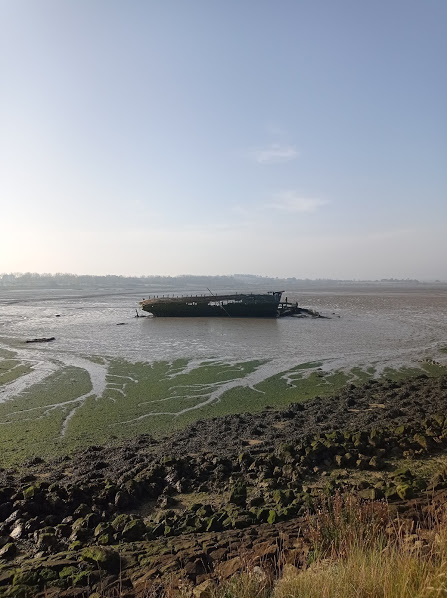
0,289,447,366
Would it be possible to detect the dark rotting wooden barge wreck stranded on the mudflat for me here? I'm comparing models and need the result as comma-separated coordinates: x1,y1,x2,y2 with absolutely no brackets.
140,291,320,318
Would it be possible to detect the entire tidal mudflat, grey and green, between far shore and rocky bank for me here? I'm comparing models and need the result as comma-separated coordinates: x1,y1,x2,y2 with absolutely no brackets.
0,287,447,460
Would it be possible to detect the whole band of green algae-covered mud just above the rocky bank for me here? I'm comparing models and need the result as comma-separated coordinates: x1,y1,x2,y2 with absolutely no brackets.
0,356,446,464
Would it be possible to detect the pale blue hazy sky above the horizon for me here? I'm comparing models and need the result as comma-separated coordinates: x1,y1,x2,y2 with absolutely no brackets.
0,0,447,280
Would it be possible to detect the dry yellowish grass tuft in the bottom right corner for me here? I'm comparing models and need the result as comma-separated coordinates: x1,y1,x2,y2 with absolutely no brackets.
213,495,447,598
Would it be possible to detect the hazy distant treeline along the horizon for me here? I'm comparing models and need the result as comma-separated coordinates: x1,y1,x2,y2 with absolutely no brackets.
0,272,428,291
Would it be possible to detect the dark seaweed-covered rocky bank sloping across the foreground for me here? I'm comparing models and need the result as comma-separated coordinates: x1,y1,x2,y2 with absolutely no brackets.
0,375,447,597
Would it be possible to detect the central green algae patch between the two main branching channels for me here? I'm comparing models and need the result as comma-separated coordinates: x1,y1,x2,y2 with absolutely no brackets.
66,360,268,445
